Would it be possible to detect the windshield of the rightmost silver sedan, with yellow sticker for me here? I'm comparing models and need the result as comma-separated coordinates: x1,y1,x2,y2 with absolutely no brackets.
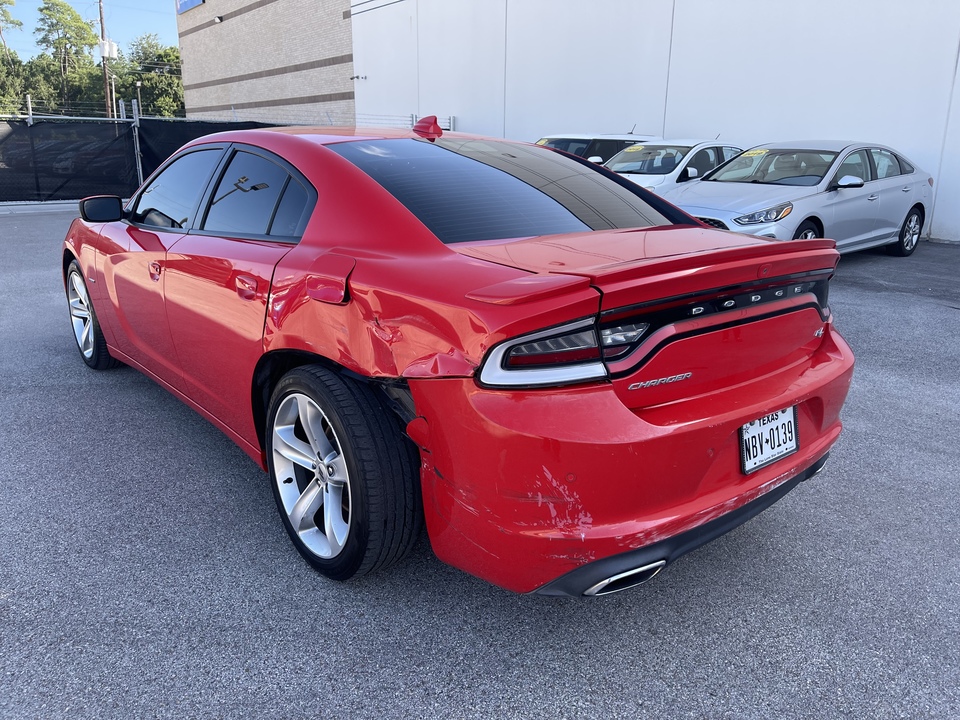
703,148,837,186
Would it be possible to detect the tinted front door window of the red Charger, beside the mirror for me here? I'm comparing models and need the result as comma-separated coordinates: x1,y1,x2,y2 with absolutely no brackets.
133,148,221,228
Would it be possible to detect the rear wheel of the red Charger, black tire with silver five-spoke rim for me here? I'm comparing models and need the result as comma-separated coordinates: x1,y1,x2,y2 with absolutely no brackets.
265,365,423,580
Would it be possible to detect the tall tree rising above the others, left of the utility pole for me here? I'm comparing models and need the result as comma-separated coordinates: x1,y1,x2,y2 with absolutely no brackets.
34,0,97,106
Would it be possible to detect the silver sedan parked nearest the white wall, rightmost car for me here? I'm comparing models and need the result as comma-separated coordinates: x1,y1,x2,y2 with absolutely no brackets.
662,141,933,256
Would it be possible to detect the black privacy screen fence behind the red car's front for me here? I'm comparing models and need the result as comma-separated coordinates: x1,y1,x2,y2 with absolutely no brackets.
0,118,278,202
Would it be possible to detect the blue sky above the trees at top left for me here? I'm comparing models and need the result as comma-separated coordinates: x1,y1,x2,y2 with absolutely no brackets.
3,0,178,60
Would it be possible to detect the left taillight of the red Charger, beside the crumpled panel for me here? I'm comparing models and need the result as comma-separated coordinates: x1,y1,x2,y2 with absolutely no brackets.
480,318,607,387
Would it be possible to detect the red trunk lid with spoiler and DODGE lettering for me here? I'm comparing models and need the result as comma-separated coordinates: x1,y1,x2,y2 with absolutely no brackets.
455,227,839,414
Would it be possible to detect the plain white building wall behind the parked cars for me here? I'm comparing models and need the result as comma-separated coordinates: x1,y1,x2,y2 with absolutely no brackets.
352,0,960,240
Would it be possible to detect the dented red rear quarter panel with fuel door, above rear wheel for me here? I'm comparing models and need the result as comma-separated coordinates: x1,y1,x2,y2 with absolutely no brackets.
264,149,600,378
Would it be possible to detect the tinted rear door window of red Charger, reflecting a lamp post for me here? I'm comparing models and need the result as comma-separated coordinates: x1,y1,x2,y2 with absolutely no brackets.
203,152,289,235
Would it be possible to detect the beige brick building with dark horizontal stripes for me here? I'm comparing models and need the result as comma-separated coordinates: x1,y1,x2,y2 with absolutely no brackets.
177,0,356,125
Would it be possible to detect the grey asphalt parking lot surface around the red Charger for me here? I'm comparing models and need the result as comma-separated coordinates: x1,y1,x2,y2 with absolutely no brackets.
0,209,960,719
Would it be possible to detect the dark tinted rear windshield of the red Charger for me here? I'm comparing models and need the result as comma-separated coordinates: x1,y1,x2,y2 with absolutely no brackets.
327,138,680,244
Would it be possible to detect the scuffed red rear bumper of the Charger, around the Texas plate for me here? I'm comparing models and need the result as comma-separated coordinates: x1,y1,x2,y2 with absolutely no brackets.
410,325,853,595
